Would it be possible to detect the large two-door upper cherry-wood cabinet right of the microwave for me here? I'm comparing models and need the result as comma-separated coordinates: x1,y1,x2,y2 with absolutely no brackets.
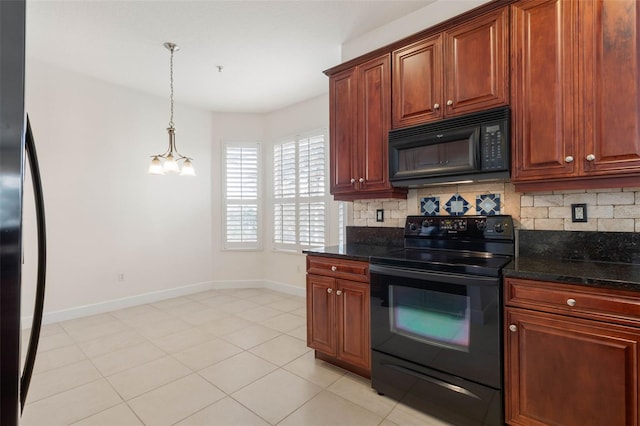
511,0,640,191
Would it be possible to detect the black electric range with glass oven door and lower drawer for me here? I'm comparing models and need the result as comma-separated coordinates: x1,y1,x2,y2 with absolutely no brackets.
369,215,515,426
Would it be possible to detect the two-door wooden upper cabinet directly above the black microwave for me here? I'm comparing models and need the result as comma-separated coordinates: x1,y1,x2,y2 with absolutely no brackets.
392,8,509,128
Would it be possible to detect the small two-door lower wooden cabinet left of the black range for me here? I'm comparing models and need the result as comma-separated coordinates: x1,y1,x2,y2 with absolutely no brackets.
307,258,371,377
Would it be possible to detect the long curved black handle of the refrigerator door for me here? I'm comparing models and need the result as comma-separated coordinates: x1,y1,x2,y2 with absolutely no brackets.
20,115,47,412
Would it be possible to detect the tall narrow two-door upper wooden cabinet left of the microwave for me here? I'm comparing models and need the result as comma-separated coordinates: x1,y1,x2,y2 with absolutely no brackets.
329,54,407,200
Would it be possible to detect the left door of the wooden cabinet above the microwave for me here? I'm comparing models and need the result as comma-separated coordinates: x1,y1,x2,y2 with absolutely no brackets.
392,35,443,129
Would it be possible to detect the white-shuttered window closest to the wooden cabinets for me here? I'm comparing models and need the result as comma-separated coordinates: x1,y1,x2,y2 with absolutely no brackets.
273,133,329,250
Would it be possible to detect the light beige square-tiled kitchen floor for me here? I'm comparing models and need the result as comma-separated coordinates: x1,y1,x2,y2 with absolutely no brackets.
21,289,444,426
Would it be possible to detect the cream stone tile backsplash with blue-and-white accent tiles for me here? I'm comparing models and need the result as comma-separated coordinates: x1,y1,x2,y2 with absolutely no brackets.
349,183,640,232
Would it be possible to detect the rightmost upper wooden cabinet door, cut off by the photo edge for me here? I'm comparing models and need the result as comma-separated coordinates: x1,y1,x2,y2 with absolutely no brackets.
579,0,640,174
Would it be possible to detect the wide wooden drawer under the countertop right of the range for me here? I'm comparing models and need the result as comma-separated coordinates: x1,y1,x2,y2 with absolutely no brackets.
505,278,640,326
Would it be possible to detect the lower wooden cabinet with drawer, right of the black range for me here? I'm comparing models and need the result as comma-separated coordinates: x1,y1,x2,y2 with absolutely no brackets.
505,278,640,426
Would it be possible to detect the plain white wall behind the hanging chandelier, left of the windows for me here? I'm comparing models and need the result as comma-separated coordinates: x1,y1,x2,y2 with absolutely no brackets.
23,60,215,318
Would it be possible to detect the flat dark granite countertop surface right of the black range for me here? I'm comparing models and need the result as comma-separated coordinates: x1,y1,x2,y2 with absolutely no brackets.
503,257,640,292
